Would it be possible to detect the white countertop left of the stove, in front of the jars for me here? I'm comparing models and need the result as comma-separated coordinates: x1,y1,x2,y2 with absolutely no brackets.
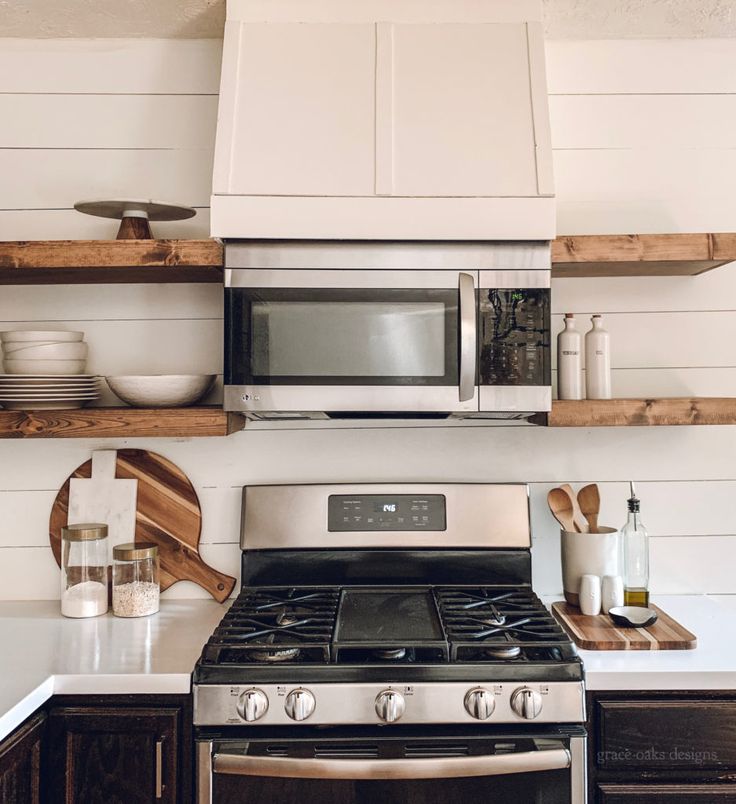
0,600,226,740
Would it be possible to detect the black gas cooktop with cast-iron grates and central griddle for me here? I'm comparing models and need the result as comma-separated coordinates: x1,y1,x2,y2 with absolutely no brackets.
194,585,582,683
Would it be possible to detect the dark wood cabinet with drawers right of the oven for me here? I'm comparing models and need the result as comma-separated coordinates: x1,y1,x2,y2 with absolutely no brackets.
588,691,736,804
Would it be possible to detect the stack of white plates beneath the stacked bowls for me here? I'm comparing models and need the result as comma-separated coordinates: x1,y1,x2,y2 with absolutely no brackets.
0,374,100,410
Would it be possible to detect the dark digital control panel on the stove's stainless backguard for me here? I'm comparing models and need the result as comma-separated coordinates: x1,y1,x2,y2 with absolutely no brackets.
327,494,447,533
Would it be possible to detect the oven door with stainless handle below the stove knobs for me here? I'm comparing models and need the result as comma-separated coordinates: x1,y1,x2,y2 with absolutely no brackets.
198,727,586,804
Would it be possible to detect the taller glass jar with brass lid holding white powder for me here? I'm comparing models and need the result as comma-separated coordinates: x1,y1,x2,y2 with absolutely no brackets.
61,522,108,617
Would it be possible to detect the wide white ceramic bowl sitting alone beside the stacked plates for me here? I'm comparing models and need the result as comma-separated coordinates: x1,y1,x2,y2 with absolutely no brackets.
105,374,217,408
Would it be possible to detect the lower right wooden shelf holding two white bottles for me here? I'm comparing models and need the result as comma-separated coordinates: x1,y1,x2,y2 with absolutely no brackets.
533,397,736,427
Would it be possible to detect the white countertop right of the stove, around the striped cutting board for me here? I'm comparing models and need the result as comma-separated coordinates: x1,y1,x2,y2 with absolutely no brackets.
545,595,736,690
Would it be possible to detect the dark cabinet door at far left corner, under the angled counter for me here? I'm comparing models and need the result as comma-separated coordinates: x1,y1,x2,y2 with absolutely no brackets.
0,714,46,804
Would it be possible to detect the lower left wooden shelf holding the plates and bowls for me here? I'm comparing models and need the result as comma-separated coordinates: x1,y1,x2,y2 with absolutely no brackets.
0,407,245,438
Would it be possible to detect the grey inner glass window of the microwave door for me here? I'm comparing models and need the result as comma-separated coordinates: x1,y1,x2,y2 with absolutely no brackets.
252,302,445,377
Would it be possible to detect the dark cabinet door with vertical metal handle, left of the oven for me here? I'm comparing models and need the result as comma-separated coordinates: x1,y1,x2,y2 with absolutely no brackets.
44,707,179,804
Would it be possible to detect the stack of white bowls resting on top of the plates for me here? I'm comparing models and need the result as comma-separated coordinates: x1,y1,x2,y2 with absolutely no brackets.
0,329,87,376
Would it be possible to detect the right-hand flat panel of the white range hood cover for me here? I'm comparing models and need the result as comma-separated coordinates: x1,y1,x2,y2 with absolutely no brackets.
388,23,552,197
